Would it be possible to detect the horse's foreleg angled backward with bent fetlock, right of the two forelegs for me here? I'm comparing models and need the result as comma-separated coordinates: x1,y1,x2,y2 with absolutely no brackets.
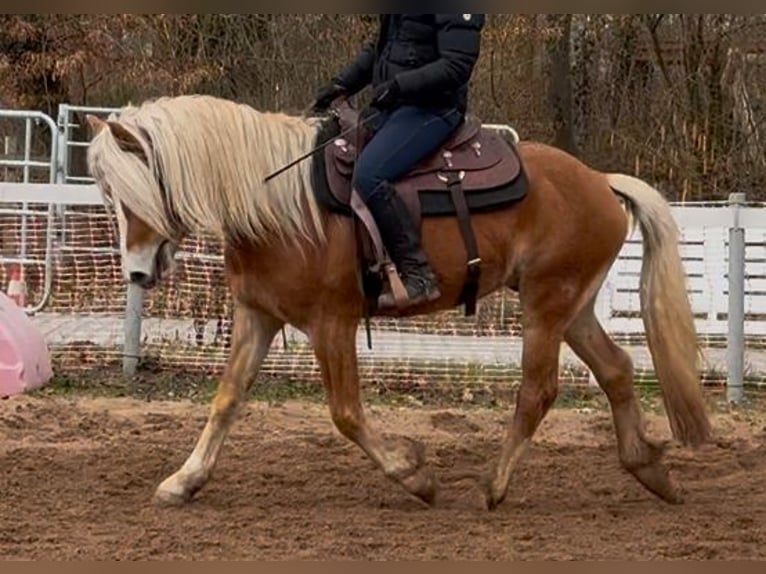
311,318,437,504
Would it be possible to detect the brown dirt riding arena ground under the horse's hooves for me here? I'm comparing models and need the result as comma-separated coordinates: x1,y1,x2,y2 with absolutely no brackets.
0,397,766,560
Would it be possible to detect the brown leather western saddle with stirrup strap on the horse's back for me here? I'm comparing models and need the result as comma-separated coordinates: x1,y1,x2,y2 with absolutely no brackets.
320,100,527,316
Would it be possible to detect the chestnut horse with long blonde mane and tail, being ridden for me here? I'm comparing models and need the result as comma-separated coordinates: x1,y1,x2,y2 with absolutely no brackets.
88,95,712,510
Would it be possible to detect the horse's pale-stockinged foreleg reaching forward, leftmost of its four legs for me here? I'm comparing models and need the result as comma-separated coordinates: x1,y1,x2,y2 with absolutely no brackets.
155,305,283,505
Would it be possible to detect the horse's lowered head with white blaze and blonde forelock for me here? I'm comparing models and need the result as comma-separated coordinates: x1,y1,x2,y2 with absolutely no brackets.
88,116,180,289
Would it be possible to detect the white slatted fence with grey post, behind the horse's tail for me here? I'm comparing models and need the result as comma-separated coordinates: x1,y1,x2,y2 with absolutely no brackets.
598,194,766,402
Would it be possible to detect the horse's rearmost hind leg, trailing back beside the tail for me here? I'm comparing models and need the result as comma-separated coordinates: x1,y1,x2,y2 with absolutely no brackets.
566,305,680,503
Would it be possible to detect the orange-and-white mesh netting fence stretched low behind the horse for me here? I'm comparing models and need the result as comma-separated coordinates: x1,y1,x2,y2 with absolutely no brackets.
0,196,766,394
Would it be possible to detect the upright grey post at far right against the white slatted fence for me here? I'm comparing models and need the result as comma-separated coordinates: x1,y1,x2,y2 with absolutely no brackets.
726,193,746,404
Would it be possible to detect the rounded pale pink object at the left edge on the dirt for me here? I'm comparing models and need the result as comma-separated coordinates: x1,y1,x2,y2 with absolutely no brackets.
0,291,53,398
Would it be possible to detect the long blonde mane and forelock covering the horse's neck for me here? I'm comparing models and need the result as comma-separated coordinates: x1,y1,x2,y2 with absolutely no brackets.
88,96,323,242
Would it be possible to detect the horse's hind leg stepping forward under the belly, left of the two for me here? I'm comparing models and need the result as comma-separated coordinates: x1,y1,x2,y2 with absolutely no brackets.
484,326,562,510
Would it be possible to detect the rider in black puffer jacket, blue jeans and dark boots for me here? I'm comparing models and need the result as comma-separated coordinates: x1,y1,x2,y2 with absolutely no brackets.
313,14,485,308
